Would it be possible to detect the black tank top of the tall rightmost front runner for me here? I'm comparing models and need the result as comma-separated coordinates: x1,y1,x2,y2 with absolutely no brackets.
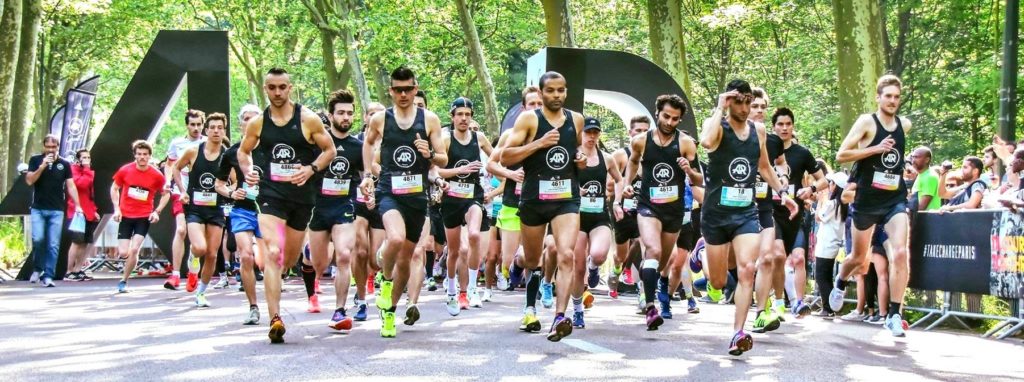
854,114,906,214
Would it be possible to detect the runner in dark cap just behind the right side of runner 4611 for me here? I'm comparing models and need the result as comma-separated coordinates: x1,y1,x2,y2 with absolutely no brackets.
571,118,623,329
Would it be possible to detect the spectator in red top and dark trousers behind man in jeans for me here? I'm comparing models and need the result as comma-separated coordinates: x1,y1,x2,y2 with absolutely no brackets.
67,148,99,281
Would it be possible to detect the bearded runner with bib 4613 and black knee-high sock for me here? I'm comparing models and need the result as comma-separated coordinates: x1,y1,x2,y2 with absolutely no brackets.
616,94,703,331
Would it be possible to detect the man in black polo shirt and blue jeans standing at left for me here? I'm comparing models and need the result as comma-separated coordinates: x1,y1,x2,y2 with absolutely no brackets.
25,134,82,287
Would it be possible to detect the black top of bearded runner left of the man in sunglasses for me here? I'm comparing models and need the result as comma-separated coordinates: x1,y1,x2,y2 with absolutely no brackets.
316,134,362,206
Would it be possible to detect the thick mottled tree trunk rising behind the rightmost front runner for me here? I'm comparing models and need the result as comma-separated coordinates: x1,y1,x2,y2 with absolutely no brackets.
833,0,885,136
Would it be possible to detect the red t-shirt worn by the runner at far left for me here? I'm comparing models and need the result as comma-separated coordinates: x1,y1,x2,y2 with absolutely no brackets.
114,163,164,218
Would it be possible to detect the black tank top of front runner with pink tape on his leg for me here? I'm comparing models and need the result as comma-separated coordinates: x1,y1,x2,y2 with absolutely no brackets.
258,103,318,204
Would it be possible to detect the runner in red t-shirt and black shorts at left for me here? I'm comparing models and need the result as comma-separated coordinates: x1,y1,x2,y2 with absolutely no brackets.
111,140,170,293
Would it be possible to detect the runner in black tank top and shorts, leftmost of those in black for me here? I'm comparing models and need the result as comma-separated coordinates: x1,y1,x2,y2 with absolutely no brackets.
172,113,227,307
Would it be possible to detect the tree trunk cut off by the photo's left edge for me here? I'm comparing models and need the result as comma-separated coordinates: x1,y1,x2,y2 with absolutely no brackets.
0,0,22,193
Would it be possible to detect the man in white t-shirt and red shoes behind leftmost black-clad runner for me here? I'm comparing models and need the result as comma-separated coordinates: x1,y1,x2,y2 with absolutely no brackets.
164,109,206,293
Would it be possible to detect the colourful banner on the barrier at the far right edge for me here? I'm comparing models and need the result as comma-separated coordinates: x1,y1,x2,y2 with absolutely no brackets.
988,211,1024,298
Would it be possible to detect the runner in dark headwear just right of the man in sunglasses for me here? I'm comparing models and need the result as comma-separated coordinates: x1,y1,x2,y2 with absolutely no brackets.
437,97,490,315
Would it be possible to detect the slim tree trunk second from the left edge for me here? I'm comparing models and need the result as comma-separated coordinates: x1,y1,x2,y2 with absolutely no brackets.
7,0,42,184
